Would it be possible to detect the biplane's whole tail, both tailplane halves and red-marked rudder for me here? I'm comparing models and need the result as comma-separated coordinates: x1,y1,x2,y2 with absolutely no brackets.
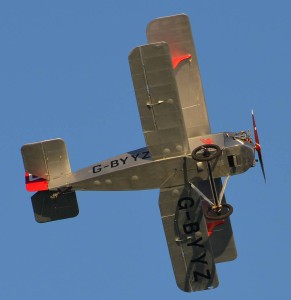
21,139,79,223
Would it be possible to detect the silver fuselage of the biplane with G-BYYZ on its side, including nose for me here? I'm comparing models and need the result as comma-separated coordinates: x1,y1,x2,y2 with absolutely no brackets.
49,133,255,191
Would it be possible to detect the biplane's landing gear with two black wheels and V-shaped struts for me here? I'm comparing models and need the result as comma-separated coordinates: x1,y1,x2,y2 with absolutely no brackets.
191,144,233,220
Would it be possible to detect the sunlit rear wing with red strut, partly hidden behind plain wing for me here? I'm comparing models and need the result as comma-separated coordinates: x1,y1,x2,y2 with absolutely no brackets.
147,14,210,138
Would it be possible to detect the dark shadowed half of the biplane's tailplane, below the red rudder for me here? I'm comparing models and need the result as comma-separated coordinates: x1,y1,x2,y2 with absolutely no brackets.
31,191,79,223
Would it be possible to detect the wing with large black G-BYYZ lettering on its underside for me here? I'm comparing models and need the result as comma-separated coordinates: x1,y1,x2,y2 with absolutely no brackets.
159,184,218,292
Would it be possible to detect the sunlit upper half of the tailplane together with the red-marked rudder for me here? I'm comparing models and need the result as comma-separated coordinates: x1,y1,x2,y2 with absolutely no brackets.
21,139,71,192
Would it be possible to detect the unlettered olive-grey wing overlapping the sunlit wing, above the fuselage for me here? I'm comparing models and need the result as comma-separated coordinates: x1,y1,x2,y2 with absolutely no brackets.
129,42,189,160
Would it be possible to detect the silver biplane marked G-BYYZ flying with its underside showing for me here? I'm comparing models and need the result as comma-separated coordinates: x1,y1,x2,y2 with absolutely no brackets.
21,14,266,292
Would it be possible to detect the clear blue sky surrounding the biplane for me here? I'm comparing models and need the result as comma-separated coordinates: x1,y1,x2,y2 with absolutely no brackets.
0,0,291,300
